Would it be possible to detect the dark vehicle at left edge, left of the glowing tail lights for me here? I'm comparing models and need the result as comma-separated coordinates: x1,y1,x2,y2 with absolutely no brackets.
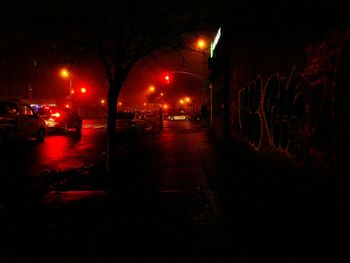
0,99,47,142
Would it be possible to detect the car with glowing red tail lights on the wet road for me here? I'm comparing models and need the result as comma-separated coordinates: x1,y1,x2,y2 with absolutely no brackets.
37,105,82,133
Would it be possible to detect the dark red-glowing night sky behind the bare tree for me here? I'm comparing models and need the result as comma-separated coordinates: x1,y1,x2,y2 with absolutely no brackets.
0,0,217,109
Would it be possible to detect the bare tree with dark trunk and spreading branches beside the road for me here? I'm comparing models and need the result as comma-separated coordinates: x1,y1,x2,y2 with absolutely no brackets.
30,0,216,173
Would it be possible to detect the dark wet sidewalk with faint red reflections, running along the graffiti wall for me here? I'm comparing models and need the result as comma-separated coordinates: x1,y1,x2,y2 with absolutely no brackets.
0,122,342,262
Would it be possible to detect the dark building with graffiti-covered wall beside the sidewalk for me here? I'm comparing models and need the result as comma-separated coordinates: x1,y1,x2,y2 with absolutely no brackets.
209,1,350,182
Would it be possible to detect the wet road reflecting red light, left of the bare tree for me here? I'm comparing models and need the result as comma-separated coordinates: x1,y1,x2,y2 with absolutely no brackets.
0,120,106,204
